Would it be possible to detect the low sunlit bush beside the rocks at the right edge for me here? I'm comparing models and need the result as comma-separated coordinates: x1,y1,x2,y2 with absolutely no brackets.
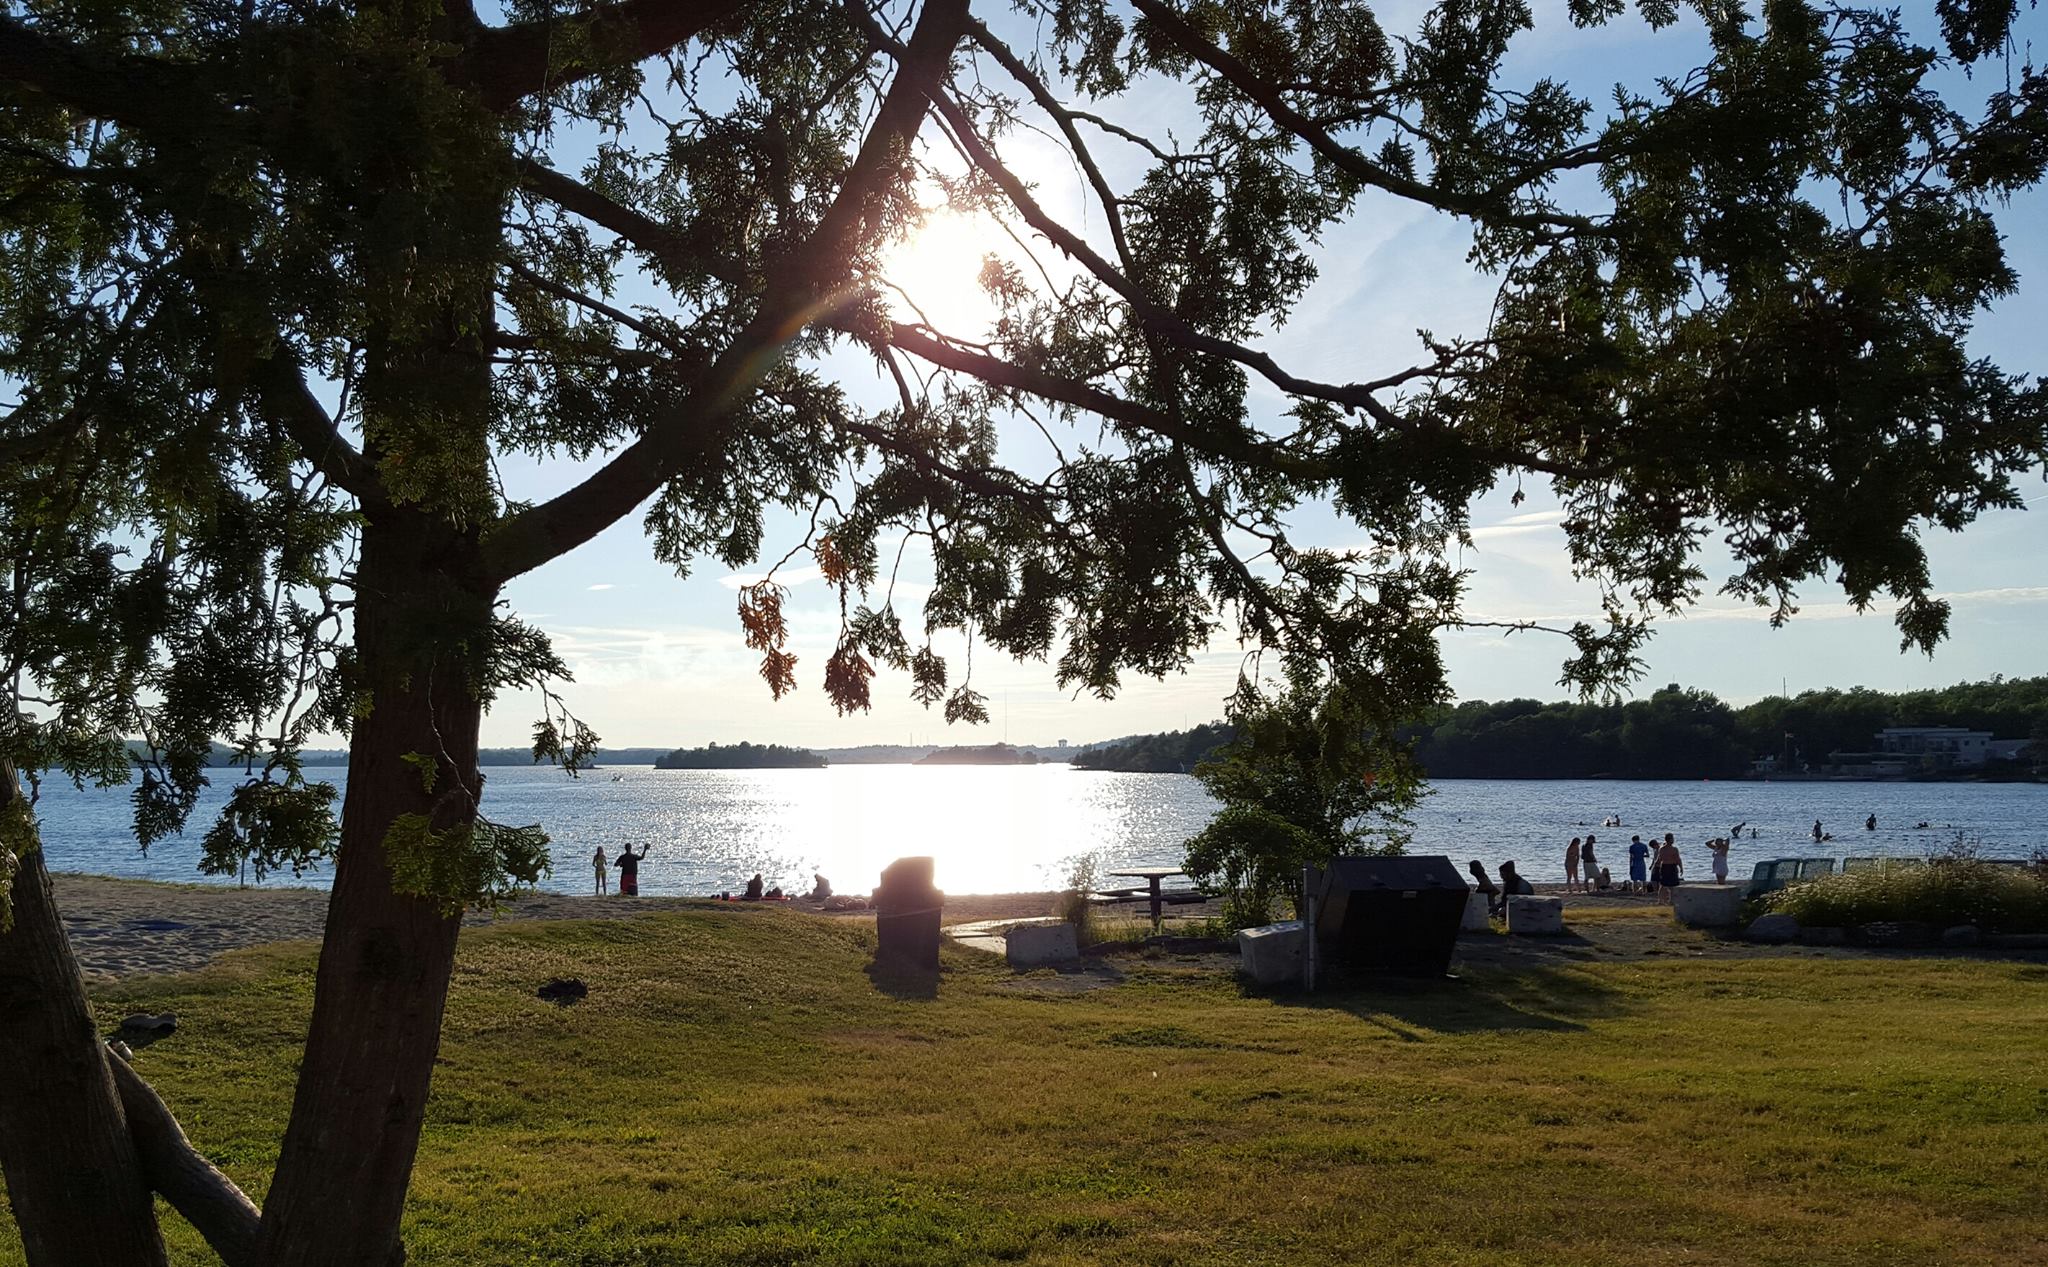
1769,860,2048,933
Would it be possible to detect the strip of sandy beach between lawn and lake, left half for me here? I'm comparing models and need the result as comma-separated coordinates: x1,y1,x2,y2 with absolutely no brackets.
51,874,1053,980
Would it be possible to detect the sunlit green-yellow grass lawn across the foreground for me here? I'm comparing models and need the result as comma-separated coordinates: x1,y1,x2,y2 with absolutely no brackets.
0,907,2048,1267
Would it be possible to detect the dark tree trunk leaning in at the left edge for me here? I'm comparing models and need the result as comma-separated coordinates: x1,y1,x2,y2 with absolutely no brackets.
0,759,164,1267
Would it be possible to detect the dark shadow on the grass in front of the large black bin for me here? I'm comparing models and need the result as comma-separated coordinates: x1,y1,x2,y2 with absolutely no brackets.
1274,966,1628,1042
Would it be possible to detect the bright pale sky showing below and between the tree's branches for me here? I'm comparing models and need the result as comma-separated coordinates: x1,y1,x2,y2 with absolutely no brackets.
483,2,2048,747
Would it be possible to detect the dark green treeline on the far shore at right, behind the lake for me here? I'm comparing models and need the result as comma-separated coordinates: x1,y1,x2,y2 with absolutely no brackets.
1073,678,2048,778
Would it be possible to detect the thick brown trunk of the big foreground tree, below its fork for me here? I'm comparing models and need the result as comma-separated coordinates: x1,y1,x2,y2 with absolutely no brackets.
256,508,496,1267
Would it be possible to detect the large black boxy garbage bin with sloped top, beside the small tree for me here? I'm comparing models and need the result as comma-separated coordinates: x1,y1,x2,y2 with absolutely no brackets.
1315,856,1470,976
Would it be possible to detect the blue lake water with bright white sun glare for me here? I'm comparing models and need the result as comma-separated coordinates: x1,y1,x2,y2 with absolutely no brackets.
19,766,2048,894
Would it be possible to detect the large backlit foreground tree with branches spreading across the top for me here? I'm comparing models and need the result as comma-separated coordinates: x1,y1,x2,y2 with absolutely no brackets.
0,0,2048,1263
